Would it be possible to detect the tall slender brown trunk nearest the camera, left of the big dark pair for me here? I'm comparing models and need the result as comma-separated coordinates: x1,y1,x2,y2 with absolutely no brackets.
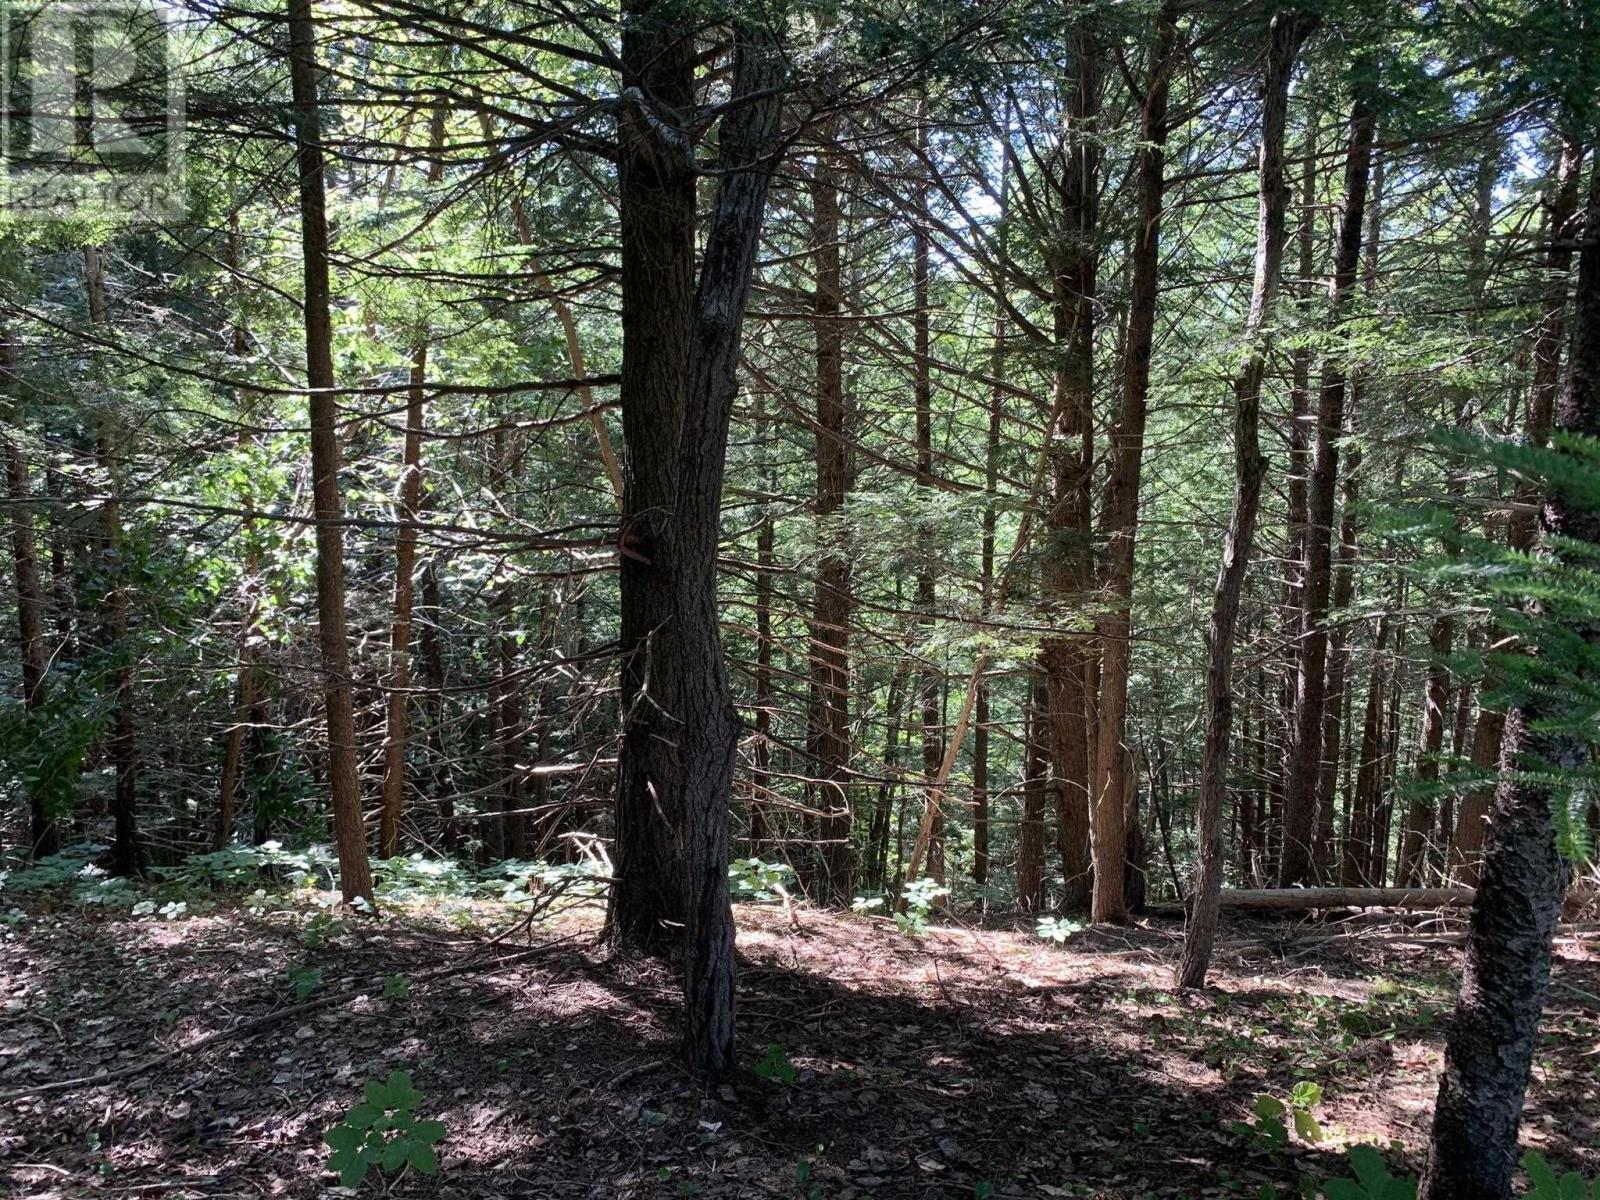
290,0,373,904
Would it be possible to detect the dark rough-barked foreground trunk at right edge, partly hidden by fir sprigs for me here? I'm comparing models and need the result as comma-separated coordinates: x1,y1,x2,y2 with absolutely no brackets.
1421,155,1600,1200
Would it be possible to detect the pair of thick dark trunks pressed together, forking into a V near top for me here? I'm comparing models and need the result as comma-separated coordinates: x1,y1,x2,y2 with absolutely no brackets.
608,3,784,1075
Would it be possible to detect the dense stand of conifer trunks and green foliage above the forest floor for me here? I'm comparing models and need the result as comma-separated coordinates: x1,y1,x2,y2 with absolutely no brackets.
0,0,1600,1200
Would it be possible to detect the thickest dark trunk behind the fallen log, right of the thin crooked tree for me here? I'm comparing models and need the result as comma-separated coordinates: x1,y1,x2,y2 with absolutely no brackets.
1278,94,1376,886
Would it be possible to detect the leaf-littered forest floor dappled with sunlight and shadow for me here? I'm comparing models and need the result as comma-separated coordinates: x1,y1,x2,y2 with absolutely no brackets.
0,904,1600,1200
